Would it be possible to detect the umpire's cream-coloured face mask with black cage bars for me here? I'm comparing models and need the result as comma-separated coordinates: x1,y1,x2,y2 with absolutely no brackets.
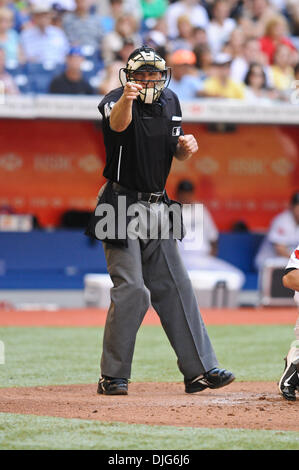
119,46,171,104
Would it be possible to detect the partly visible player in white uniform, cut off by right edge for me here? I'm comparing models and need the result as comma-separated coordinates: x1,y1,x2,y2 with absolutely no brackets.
278,245,299,401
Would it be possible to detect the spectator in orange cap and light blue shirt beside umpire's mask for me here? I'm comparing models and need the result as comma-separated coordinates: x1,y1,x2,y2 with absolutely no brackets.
169,49,203,100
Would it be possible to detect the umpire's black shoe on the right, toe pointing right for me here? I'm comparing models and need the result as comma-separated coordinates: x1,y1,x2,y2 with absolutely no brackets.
184,367,235,393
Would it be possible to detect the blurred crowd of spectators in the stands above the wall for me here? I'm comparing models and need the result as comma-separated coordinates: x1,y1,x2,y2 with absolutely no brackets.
0,0,299,103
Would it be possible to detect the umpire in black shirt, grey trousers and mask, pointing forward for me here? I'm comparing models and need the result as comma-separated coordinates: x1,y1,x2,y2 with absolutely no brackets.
86,46,235,395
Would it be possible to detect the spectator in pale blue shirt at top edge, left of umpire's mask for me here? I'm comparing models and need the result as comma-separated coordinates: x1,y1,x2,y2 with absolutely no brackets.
63,0,103,51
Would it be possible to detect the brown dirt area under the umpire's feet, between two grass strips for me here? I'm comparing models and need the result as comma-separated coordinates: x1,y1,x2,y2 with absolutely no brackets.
0,382,299,431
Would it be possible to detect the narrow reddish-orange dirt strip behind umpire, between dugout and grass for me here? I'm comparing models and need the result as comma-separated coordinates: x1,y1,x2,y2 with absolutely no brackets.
0,307,298,327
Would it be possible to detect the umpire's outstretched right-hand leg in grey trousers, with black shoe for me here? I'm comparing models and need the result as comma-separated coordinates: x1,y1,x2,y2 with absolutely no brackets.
143,239,234,393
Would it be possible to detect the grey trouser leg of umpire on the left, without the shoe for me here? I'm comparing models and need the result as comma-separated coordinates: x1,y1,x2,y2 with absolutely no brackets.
101,239,149,392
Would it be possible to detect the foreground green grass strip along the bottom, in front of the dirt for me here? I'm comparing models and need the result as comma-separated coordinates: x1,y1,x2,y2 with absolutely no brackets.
0,413,299,450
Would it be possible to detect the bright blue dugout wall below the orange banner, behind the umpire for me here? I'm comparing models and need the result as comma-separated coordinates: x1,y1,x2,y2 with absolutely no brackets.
0,229,263,290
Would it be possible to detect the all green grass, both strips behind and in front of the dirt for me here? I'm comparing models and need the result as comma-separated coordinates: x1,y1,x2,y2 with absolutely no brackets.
0,325,299,450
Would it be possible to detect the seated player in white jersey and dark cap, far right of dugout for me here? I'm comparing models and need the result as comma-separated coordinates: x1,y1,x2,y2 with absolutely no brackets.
255,191,299,270
